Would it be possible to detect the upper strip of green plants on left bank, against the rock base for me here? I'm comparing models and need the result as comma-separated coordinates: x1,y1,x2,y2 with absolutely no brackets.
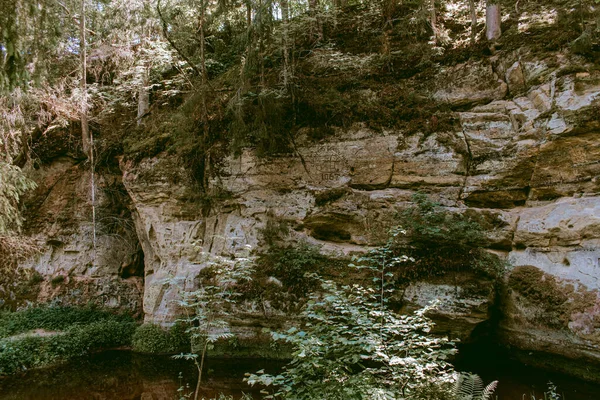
0,306,133,338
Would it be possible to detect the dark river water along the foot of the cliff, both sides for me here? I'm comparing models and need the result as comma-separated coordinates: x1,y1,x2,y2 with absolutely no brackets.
0,351,600,400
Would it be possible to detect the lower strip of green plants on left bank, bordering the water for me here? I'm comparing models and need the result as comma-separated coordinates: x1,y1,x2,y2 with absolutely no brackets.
0,320,135,375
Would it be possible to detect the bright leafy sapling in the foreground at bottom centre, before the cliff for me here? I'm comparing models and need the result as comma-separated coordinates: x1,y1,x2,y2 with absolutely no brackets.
247,281,455,400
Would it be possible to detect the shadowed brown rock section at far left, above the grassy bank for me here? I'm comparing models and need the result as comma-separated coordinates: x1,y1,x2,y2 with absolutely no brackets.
16,157,143,315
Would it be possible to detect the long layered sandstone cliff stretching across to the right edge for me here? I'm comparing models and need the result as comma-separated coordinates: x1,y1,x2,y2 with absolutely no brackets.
12,50,600,378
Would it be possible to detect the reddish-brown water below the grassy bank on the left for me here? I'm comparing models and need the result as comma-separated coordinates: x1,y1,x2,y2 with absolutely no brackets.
0,351,281,400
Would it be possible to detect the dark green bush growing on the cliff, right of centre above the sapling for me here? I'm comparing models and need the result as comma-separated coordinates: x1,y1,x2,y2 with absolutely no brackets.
392,194,505,280
